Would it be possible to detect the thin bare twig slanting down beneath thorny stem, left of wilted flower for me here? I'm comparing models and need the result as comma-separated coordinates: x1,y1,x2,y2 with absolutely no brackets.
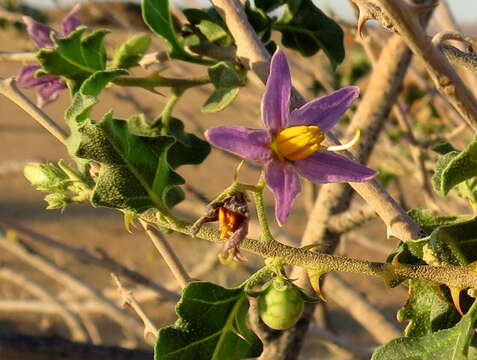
139,219,192,288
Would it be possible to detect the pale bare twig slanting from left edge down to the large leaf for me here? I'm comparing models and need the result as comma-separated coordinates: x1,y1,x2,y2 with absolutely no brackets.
0,78,67,144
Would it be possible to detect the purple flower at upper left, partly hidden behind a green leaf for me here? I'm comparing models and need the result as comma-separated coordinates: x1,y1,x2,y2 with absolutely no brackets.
16,4,80,107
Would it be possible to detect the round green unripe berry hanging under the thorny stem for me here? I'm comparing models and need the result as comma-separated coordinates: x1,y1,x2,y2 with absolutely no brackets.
258,277,304,330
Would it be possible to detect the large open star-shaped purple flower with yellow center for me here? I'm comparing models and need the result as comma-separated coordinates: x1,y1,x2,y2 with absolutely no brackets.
205,51,376,225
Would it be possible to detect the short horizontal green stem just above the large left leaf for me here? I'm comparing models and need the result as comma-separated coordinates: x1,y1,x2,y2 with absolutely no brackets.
113,73,210,91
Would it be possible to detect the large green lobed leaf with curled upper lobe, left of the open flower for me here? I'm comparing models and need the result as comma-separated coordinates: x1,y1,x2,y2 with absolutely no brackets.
66,70,184,212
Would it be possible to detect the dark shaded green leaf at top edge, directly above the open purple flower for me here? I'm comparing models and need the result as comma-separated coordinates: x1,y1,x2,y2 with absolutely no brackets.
273,0,345,68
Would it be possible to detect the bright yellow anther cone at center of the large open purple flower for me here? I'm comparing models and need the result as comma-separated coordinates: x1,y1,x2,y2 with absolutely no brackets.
270,125,326,160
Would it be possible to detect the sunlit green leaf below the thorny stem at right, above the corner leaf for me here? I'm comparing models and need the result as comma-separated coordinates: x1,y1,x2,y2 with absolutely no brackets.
397,280,460,337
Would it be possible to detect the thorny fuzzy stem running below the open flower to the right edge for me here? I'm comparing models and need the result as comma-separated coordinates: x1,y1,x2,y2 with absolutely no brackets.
142,211,477,289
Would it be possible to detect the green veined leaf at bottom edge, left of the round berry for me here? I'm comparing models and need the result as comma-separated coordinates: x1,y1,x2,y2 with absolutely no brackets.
154,282,262,360
